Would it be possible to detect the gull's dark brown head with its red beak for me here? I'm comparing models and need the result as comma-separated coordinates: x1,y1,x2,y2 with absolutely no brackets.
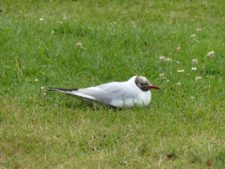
135,76,159,91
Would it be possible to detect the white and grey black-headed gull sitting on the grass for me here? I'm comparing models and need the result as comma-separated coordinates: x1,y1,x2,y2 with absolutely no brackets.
49,76,159,108
